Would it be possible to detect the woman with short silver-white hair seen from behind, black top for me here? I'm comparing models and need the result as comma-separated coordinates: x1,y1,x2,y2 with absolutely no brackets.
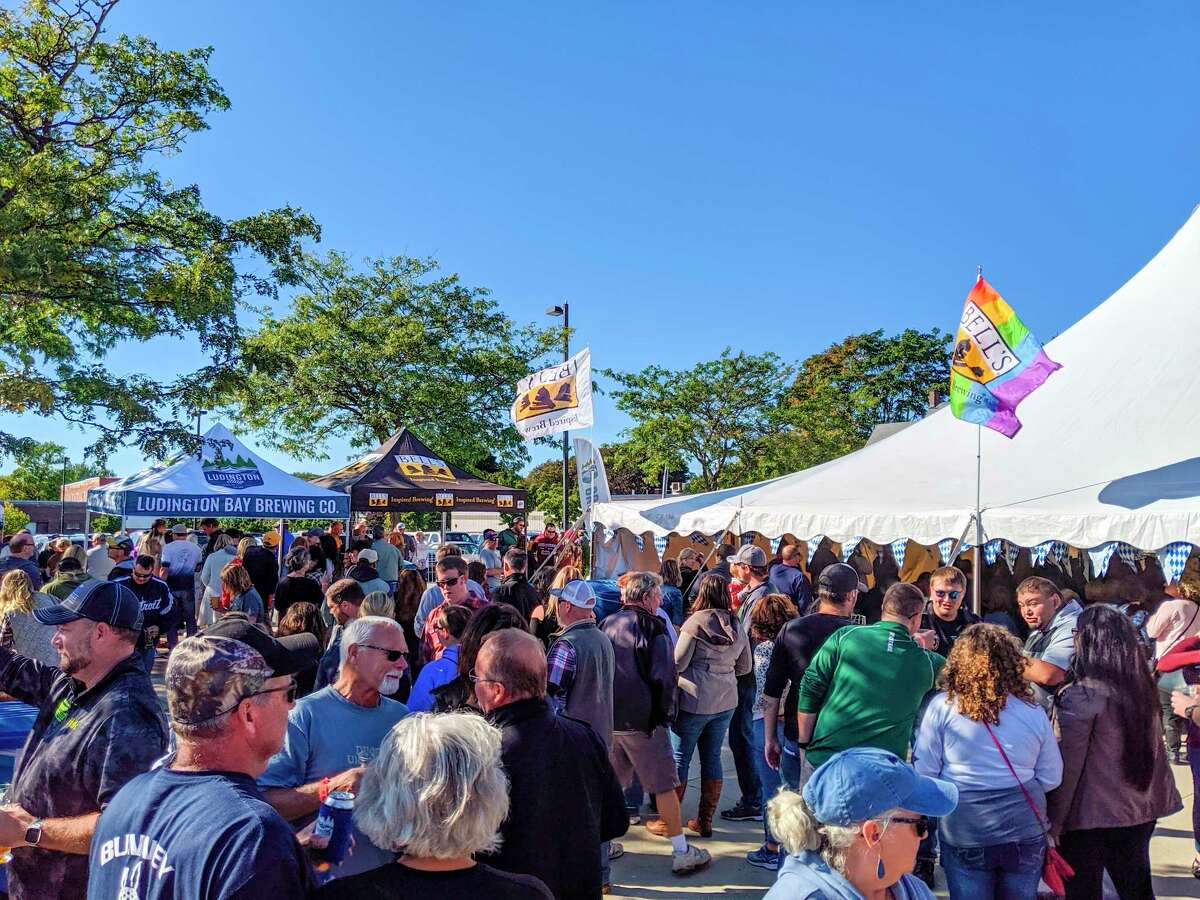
317,713,553,900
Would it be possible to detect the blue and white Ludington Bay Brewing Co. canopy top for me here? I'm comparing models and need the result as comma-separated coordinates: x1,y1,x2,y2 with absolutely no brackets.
88,424,350,518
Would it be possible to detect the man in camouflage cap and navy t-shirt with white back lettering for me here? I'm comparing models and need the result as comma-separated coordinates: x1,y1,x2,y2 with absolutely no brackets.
88,613,318,900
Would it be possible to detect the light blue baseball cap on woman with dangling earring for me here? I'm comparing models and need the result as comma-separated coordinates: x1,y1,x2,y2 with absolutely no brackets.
804,746,959,826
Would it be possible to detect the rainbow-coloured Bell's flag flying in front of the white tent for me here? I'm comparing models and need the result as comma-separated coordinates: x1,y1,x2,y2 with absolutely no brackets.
950,275,1062,438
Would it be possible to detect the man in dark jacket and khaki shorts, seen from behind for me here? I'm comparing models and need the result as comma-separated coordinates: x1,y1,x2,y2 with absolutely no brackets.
600,572,712,875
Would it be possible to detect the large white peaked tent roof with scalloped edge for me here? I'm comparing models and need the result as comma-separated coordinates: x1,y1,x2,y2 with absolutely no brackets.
594,210,1200,550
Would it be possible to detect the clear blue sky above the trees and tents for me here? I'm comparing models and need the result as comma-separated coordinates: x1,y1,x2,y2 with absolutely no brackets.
9,0,1200,473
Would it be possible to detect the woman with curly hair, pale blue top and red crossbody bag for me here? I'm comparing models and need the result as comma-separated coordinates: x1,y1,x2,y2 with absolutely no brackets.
913,623,1062,900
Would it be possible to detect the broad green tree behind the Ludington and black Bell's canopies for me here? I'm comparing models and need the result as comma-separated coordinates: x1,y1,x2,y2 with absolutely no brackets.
228,253,559,476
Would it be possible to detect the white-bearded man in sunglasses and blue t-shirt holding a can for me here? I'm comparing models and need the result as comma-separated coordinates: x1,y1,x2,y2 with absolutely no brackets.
258,616,408,877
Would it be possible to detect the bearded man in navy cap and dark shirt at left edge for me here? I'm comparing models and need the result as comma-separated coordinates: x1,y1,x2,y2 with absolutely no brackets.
0,580,167,900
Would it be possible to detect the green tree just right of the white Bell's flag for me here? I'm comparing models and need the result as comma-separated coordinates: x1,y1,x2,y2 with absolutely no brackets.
601,348,794,491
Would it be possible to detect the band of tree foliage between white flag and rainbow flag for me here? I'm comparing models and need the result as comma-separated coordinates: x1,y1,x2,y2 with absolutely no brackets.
604,329,950,491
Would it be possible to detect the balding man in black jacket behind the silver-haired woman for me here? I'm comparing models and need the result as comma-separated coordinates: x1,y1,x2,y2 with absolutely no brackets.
470,629,629,900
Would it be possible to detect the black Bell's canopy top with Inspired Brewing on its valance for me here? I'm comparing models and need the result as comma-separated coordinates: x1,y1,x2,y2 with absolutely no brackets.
312,428,526,512
